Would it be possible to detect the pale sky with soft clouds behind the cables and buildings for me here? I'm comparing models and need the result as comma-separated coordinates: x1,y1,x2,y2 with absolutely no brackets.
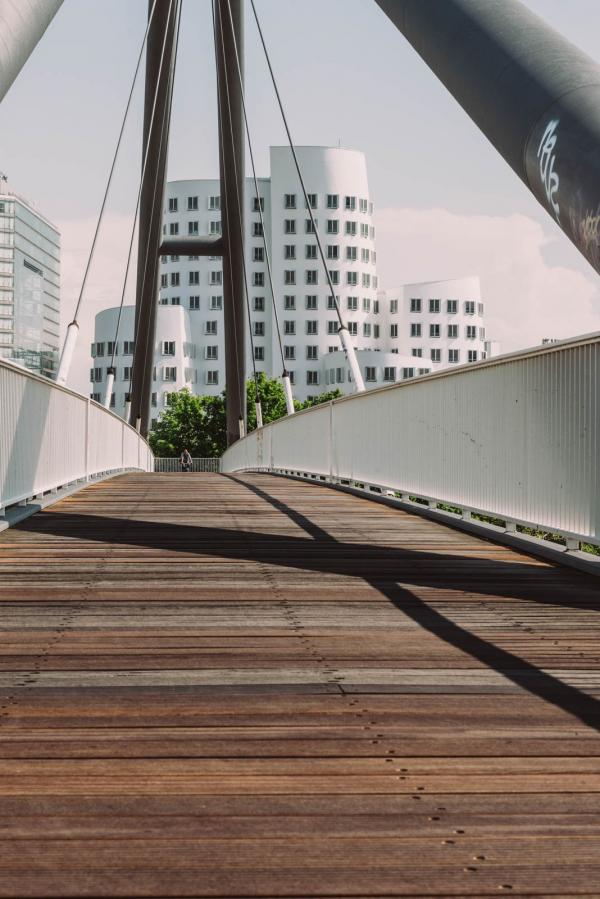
0,0,600,392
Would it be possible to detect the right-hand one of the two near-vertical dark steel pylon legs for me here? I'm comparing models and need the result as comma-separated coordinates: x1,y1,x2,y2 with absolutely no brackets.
215,0,246,446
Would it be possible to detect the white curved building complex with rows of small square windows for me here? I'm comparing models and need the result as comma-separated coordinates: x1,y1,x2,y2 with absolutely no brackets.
92,147,496,426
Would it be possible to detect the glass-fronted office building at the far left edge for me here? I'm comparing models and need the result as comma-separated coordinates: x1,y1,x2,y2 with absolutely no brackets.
0,182,60,378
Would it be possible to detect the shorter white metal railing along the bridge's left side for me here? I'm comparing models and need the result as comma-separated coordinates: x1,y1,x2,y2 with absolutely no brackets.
0,359,154,515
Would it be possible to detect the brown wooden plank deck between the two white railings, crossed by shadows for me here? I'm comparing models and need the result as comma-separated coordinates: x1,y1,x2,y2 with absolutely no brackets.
0,474,600,897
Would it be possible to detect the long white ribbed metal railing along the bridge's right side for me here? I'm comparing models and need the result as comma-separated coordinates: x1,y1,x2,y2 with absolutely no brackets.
222,334,600,549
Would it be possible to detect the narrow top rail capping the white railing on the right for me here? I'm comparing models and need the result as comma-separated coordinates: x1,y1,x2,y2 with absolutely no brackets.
250,331,600,428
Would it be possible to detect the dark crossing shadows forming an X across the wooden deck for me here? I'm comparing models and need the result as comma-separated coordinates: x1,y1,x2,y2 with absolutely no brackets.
8,476,600,730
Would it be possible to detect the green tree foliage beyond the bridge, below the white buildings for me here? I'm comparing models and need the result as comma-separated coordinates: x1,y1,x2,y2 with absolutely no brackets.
148,372,342,458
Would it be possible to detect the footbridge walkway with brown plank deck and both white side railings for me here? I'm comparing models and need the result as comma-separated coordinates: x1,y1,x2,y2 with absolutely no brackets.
0,335,600,897
